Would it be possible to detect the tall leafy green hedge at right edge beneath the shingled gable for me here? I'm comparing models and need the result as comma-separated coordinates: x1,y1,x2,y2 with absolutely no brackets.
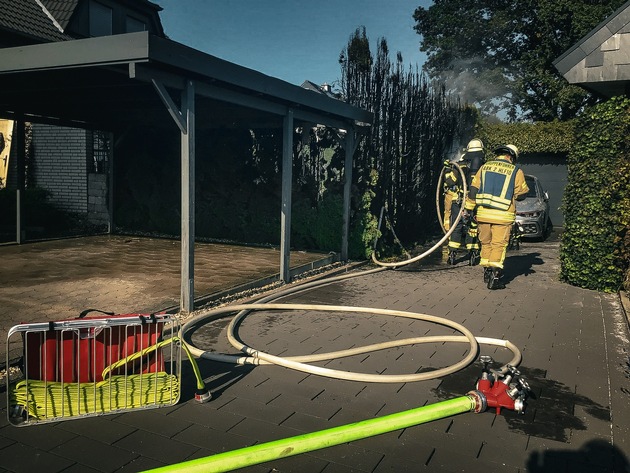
560,97,630,292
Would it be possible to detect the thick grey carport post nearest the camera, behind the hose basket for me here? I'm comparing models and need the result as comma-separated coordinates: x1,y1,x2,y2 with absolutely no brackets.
180,80,195,314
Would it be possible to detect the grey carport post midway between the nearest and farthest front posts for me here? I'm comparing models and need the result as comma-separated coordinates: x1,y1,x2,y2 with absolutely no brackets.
280,109,293,283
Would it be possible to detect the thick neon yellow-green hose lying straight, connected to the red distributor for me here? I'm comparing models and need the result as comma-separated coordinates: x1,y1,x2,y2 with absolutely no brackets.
143,394,480,473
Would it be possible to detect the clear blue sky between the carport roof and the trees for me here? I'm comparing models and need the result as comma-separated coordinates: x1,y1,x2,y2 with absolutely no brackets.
153,0,433,85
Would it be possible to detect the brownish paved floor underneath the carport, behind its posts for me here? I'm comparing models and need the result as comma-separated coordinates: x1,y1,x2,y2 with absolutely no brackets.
0,235,328,360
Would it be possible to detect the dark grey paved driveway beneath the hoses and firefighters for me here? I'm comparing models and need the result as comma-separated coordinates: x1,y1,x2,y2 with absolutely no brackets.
0,233,630,473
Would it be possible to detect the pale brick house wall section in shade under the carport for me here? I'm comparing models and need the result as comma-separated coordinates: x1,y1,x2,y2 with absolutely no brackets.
32,123,88,213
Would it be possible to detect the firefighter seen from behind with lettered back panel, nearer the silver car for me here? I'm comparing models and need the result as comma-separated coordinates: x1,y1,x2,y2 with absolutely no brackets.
465,144,529,289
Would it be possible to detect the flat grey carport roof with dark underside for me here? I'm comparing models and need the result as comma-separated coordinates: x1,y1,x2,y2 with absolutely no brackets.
0,32,372,131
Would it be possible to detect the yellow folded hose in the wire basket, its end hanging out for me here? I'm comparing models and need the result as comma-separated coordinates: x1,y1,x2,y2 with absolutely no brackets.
9,337,205,421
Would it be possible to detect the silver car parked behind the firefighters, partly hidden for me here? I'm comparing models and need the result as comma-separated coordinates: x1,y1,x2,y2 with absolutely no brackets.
516,174,553,240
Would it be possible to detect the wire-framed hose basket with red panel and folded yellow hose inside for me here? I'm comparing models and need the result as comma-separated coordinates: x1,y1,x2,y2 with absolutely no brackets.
7,314,181,426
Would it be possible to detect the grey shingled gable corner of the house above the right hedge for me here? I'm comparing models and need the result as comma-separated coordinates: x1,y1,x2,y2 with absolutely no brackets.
553,1,630,97
